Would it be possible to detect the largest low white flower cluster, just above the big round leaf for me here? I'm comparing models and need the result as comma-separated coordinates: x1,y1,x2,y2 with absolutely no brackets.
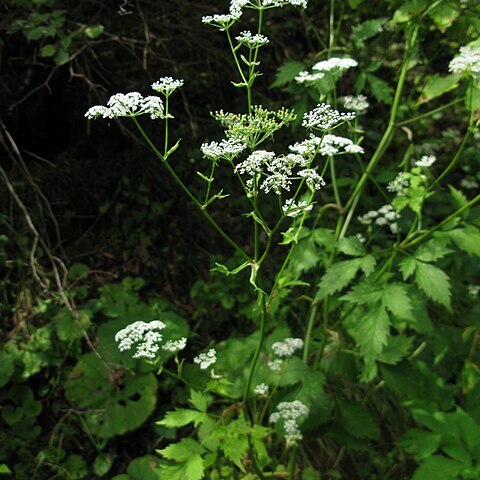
115,320,165,359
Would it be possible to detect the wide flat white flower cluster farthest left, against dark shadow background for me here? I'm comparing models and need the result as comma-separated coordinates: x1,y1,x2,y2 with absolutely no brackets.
85,92,164,120
